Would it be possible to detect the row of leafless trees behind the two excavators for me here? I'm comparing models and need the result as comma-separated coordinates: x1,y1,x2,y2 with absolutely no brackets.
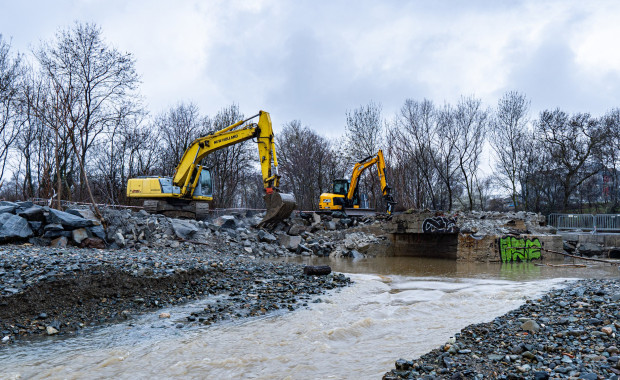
0,23,620,212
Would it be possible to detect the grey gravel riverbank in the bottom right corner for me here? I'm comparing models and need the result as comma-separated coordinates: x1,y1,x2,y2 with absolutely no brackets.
383,280,620,380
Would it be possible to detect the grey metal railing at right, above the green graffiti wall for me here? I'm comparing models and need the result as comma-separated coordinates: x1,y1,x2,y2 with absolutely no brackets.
547,214,620,232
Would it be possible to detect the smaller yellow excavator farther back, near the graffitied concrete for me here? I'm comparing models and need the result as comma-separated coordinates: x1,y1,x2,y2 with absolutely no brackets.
319,149,396,216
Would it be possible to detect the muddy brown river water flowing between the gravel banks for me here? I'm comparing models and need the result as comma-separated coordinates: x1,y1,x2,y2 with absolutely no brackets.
0,258,619,379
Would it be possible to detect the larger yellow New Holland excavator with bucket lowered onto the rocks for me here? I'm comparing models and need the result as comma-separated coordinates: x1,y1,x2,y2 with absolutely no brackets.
127,111,296,225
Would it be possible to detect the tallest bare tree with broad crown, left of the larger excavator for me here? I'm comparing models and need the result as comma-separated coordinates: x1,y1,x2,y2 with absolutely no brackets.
36,23,138,211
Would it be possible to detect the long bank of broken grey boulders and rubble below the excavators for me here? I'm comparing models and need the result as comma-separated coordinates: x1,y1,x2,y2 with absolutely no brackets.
0,201,385,258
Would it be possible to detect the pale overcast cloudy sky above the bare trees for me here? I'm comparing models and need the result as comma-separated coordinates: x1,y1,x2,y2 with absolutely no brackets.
0,0,620,135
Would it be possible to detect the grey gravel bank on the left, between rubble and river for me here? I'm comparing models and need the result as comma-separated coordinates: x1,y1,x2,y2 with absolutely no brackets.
0,243,350,347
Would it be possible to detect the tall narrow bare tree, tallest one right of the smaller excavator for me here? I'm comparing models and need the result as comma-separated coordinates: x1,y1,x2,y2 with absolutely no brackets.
489,91,531,210
